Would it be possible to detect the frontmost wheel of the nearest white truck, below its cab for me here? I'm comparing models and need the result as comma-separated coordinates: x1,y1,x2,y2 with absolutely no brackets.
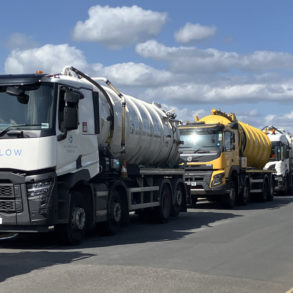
56,191,89,245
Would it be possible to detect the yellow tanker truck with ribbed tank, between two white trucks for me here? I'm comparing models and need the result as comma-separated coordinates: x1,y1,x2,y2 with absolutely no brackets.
179,109,273,208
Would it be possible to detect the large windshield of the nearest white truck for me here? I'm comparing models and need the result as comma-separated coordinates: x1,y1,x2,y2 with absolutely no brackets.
0,83,54,133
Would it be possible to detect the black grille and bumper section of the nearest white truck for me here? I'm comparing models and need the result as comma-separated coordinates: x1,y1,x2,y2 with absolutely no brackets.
0,171,56,232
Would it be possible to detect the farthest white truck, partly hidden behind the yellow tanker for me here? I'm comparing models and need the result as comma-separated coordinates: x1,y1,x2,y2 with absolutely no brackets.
263,126,293,194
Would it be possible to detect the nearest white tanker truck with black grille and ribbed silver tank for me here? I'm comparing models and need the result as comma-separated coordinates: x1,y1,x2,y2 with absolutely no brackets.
0,67,186,244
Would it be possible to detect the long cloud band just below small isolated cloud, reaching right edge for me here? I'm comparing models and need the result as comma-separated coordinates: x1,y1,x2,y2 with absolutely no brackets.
136,40,293,73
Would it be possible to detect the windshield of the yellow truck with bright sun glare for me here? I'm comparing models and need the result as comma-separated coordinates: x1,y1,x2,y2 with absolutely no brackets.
180,128,222,151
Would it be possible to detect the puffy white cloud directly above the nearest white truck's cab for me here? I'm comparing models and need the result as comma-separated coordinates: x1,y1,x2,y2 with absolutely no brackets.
5,44,87,73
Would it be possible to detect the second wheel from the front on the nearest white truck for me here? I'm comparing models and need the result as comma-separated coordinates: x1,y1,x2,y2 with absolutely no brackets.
99,189,123,235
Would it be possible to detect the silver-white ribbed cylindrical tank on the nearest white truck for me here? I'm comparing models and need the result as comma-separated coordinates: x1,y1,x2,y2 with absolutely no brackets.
98,86,180,167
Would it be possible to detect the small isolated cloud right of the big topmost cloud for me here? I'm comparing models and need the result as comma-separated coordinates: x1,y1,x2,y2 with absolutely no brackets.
174,22,217,43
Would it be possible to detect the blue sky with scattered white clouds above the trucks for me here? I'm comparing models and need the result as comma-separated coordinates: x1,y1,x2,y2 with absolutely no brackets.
0,0,293,133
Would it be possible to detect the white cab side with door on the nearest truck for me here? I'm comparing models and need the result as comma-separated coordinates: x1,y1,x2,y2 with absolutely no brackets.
56,85,98,174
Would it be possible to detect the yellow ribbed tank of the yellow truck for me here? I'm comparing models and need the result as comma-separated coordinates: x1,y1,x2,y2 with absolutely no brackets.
200,111,271,169
